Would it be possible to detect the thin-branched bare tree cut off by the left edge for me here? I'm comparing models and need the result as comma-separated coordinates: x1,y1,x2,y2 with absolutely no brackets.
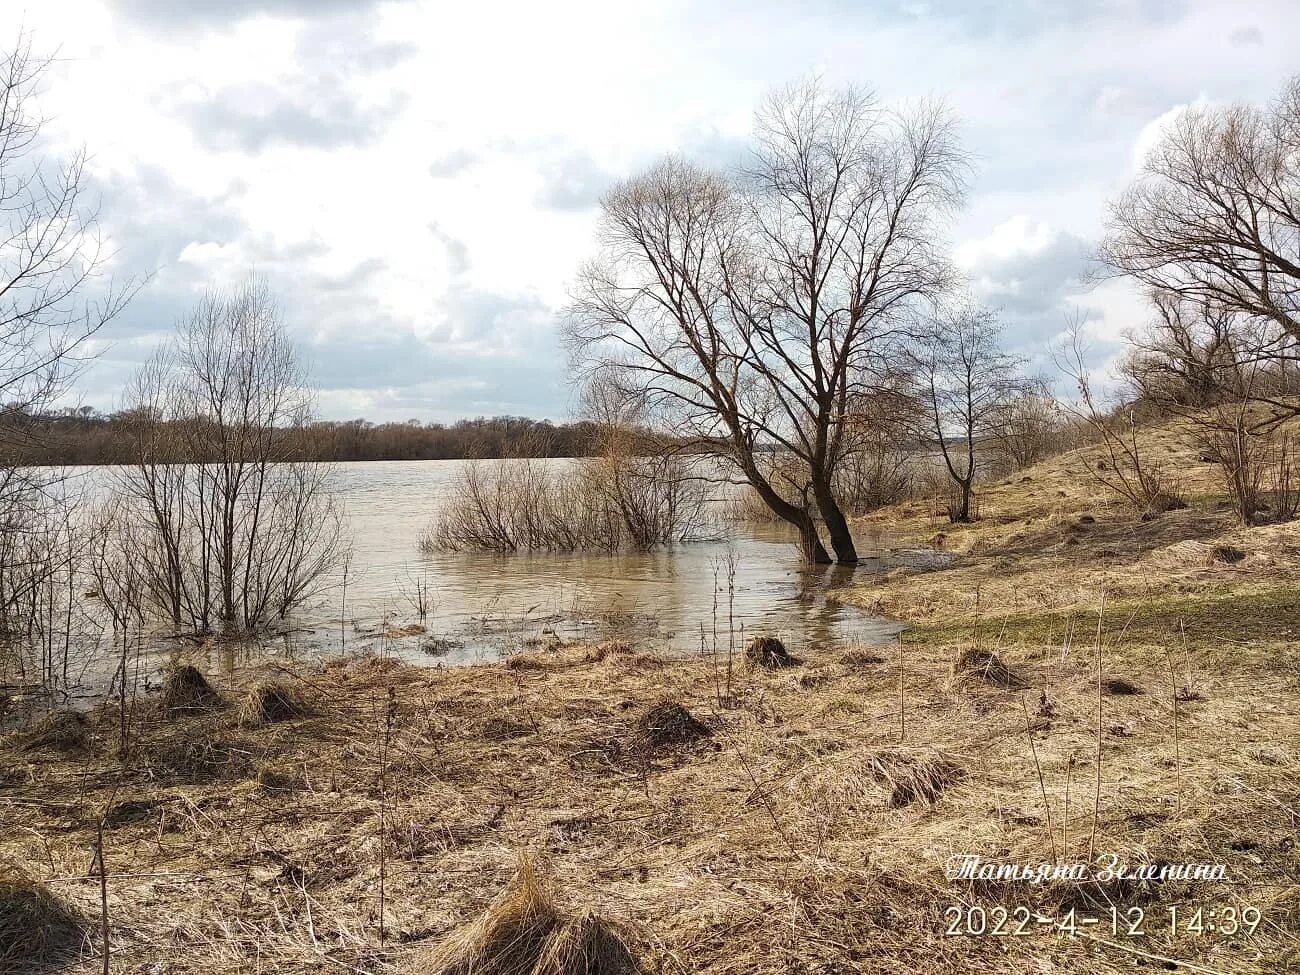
0,34,138,686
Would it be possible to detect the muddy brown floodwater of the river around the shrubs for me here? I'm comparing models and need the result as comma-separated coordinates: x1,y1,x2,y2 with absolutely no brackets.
7,460,945,684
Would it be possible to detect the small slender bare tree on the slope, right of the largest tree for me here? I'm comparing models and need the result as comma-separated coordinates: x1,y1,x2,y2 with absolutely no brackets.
910,304,1031,521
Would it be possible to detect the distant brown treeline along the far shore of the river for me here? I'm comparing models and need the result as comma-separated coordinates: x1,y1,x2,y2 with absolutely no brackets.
0,407,608,465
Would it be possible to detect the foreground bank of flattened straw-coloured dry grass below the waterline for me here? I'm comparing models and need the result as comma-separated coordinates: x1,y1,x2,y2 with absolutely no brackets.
0,629,1300,972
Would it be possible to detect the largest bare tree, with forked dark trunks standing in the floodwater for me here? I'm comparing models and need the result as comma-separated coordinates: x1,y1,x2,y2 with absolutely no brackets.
568,82,965,563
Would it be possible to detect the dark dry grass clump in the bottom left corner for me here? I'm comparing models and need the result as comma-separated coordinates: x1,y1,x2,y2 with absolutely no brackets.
0,866,83,972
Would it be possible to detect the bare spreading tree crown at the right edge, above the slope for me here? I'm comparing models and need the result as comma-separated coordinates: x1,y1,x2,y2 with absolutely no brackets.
1101,75,1300,348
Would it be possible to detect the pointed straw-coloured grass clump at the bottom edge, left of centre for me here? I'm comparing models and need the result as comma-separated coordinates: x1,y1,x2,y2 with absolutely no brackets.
416,858,641,975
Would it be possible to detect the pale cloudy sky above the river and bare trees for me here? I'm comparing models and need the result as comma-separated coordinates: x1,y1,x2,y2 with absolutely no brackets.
10,0,1300,421
